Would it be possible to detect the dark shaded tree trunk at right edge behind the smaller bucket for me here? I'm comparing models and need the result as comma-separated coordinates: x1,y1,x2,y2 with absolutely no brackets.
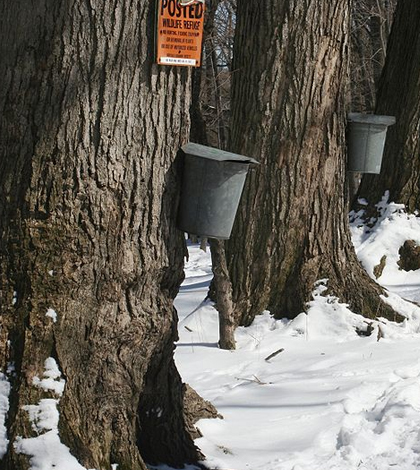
360,1,420,212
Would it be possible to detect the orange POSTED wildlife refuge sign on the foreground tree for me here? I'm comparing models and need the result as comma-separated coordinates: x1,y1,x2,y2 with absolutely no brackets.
157,0,204,67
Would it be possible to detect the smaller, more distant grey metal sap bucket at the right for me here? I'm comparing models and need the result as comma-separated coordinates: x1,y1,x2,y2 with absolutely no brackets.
348,113,395,174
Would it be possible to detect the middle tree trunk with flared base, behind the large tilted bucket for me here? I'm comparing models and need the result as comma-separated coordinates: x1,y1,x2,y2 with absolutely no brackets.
227,0,400,324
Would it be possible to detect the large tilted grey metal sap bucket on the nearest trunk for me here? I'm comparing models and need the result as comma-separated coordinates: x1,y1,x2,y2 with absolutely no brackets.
178,143,258,240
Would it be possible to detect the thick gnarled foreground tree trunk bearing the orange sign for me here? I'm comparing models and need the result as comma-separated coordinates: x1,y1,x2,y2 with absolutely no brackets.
0,0,205,470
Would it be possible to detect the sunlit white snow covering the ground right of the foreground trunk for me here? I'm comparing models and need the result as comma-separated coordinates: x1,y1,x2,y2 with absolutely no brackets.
175,200,420,470
